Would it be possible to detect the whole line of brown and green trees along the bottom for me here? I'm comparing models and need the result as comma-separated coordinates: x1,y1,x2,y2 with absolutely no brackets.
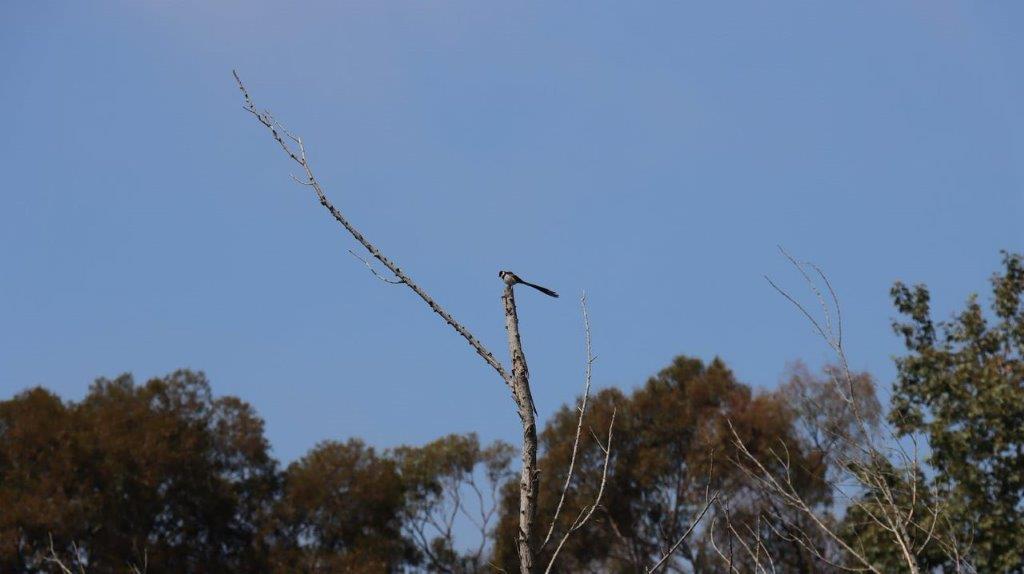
0,254,1024,573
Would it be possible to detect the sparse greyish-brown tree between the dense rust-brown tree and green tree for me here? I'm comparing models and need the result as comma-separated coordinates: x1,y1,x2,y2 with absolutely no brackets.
733,361,882,573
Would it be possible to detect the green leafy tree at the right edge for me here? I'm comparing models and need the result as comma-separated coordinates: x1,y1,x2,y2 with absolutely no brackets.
890,253,1024,572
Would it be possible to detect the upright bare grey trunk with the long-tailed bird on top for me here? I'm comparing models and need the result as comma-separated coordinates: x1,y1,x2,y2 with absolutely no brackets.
502,284,540,574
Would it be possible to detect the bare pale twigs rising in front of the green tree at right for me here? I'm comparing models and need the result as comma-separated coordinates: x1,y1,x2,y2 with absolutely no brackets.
712,250,972,574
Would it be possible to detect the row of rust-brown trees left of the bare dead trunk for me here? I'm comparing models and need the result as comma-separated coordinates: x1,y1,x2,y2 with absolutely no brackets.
0,370,513,573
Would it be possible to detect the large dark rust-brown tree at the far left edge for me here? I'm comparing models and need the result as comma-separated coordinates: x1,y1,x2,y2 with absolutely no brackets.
0,370,276,573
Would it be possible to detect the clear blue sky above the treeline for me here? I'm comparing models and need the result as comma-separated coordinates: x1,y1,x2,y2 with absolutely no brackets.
0,0,1024,461
